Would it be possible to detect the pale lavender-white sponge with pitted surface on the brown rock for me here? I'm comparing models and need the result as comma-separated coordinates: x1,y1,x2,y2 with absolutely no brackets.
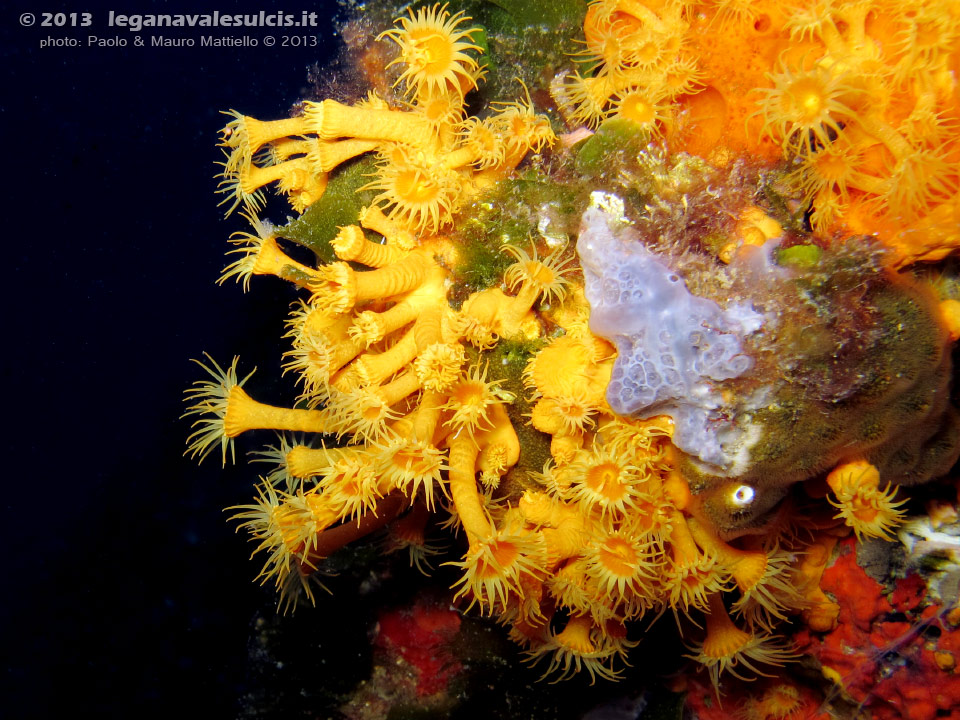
577,196,763,474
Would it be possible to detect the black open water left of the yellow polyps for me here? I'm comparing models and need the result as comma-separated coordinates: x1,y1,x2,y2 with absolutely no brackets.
0,0,338,718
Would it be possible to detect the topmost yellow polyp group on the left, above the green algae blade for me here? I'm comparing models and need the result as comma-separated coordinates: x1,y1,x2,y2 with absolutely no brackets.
219,5,554,234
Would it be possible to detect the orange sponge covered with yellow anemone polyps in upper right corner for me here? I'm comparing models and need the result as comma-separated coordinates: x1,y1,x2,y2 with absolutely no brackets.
553,0,960,267
